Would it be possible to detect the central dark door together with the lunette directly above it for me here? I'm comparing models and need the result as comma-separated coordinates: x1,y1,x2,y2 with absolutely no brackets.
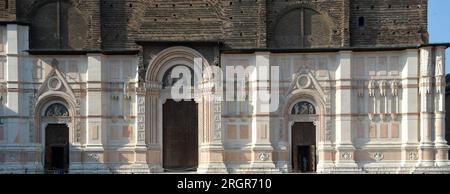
162,64,198,172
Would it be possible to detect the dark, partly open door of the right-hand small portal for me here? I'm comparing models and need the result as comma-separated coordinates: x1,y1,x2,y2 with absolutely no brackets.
292,123,316,172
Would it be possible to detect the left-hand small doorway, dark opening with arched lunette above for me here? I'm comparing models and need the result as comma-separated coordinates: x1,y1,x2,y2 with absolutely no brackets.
42,102,71,174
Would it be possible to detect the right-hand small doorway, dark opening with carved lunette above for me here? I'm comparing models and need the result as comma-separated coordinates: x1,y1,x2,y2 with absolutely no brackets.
290,101,317,173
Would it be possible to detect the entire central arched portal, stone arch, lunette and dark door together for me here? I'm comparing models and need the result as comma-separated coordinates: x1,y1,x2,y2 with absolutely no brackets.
145,46,214,172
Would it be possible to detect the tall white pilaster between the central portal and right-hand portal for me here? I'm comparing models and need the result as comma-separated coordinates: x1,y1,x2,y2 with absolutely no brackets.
249,52,275,172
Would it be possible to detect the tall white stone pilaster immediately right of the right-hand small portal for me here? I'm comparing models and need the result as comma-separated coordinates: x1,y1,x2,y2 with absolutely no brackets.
336,51,358,171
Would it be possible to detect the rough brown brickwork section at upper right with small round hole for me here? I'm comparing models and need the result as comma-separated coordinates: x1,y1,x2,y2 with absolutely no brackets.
350,0,428,46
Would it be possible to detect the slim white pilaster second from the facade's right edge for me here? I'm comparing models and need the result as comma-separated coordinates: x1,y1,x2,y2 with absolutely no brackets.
417,47,435,167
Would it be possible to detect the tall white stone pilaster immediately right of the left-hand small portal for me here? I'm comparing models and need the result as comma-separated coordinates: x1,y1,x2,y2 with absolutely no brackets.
82,53,108,173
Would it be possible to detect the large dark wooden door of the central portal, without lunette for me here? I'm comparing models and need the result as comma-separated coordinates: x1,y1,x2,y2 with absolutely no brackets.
163,100,198,171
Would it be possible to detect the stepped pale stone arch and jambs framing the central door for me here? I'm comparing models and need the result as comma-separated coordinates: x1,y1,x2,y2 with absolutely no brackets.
143,46,226,172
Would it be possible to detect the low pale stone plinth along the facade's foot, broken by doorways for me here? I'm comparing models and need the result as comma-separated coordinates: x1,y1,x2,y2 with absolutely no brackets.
0,163,450,174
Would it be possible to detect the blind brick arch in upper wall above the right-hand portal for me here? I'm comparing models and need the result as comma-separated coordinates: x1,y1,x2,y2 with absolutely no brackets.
269,2,337,48
